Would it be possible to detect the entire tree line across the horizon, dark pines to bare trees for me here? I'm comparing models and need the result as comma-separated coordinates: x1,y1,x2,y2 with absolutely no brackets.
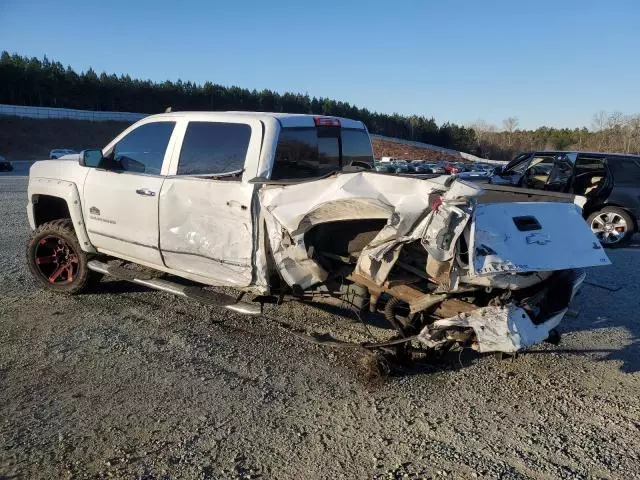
0,51,640,160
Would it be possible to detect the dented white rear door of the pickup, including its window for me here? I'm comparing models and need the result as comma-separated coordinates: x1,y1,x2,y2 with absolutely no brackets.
159,117,263,286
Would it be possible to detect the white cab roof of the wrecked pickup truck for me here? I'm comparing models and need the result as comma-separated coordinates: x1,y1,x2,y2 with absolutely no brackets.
145,112,365,129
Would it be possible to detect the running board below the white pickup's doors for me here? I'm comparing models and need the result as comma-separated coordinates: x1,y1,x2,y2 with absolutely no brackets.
87,260,262,315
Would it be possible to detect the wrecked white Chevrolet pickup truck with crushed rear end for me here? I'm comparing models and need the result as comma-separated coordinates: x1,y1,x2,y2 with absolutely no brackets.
27,112,609,360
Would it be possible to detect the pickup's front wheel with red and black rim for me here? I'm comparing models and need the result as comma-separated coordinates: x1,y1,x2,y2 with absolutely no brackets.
27,218,100,294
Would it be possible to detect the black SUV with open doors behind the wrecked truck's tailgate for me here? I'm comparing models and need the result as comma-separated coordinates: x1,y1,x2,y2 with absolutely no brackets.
490,152,640,247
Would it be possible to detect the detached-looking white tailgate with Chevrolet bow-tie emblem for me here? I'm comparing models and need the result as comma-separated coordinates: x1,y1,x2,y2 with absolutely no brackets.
469,202,611,275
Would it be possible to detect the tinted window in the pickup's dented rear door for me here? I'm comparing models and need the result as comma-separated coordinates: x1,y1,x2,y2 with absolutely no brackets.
177,122,251,175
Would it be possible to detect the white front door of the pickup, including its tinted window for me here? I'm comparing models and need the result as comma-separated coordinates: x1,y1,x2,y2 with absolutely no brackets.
83,121,175,266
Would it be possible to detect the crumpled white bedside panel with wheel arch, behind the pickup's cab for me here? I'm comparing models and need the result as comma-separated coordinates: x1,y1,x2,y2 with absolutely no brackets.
260,172,482,288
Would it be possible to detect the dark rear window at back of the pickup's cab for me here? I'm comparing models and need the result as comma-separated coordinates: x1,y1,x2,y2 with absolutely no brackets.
271,127,373,180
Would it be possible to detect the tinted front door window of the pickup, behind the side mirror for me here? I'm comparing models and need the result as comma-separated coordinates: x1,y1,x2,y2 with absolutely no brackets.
110,122,175,175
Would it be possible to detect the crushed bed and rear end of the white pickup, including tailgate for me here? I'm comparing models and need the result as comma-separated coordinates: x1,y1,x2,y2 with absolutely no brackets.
259,172,610,352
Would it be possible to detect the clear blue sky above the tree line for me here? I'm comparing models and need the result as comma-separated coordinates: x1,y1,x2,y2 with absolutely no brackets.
0,0,640,128
